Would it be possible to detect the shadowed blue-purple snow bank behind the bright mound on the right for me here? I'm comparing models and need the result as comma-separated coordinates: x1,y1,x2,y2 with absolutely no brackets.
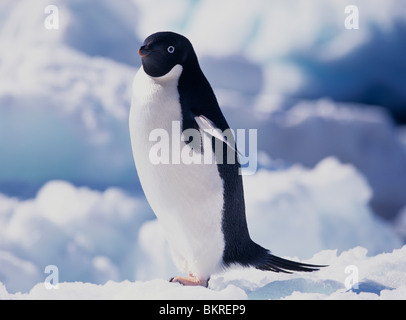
224,96,406,219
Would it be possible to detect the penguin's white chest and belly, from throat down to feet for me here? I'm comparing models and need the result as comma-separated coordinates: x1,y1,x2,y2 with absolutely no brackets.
129,65,224,277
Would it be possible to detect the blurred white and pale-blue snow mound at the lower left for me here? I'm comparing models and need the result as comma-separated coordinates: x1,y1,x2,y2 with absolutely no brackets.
0,181,152,291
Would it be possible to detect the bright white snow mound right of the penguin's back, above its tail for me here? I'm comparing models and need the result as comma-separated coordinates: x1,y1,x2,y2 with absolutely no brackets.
244,158,401,258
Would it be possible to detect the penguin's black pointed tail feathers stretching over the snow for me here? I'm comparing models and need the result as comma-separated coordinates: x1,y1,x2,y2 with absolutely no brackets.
253,251,327,273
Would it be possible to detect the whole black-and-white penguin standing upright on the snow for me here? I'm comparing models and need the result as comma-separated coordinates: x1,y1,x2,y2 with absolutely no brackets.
129,31,323,287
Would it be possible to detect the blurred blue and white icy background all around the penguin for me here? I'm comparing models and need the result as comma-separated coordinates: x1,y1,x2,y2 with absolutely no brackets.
0,0,406,299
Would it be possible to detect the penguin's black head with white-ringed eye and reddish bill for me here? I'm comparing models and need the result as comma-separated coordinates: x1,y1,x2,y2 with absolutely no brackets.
138,32,197,77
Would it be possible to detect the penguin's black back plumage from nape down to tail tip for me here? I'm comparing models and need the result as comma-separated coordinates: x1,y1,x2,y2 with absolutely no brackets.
178,31,322,273
